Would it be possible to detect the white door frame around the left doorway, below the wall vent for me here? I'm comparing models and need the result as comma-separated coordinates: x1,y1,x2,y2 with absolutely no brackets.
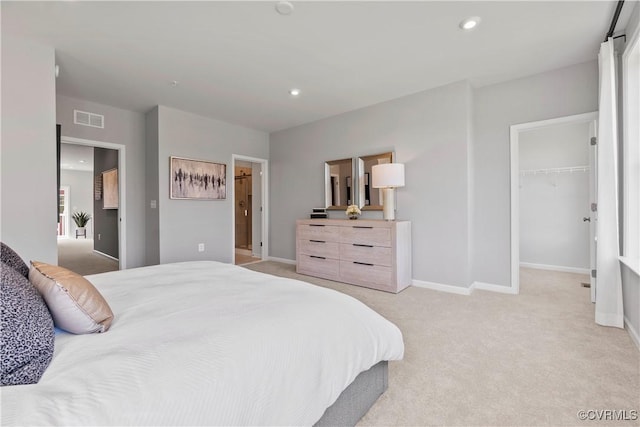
60,136,127,270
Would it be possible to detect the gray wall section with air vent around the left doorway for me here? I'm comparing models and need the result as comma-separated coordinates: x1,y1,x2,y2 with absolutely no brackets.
52,95,146,268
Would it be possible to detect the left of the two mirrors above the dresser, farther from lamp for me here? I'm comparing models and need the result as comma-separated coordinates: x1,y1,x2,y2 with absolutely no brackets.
324,159,354,210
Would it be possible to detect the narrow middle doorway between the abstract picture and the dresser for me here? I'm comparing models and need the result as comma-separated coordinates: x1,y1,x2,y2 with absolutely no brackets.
232,155,267,264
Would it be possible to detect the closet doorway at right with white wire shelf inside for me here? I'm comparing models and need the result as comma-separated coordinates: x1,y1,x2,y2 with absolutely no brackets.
511,112,597,300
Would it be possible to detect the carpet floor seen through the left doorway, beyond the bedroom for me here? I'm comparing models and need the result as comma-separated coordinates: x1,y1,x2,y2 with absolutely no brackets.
58,239,119,276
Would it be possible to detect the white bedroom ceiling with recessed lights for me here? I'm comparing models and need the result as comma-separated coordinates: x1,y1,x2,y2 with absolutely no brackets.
1,1,635,132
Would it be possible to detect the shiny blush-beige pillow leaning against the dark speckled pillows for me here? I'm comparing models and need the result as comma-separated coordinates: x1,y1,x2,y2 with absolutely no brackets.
29,261,113,334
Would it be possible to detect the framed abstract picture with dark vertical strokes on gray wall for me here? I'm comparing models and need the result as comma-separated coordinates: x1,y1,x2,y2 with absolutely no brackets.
169,156,227,200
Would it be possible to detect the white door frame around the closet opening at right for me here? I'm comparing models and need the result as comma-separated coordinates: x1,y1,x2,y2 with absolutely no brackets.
510,111,598,294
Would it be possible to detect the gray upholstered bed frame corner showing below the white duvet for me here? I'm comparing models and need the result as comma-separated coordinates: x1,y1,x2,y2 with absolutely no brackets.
314,360,389,427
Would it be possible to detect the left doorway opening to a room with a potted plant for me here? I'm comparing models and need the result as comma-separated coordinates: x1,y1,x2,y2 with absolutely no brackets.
58,136,126,275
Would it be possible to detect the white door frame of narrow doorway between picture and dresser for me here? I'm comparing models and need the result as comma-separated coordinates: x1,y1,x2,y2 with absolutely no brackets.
227,154,269,264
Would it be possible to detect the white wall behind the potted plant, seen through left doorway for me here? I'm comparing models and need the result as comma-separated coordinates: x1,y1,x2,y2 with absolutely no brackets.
60,169,93,239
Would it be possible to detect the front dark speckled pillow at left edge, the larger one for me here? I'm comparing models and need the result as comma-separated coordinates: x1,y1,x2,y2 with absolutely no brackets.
0,263,54,386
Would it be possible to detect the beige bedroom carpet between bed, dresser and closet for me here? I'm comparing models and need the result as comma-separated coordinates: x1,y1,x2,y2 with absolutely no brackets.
246,261,640,426
